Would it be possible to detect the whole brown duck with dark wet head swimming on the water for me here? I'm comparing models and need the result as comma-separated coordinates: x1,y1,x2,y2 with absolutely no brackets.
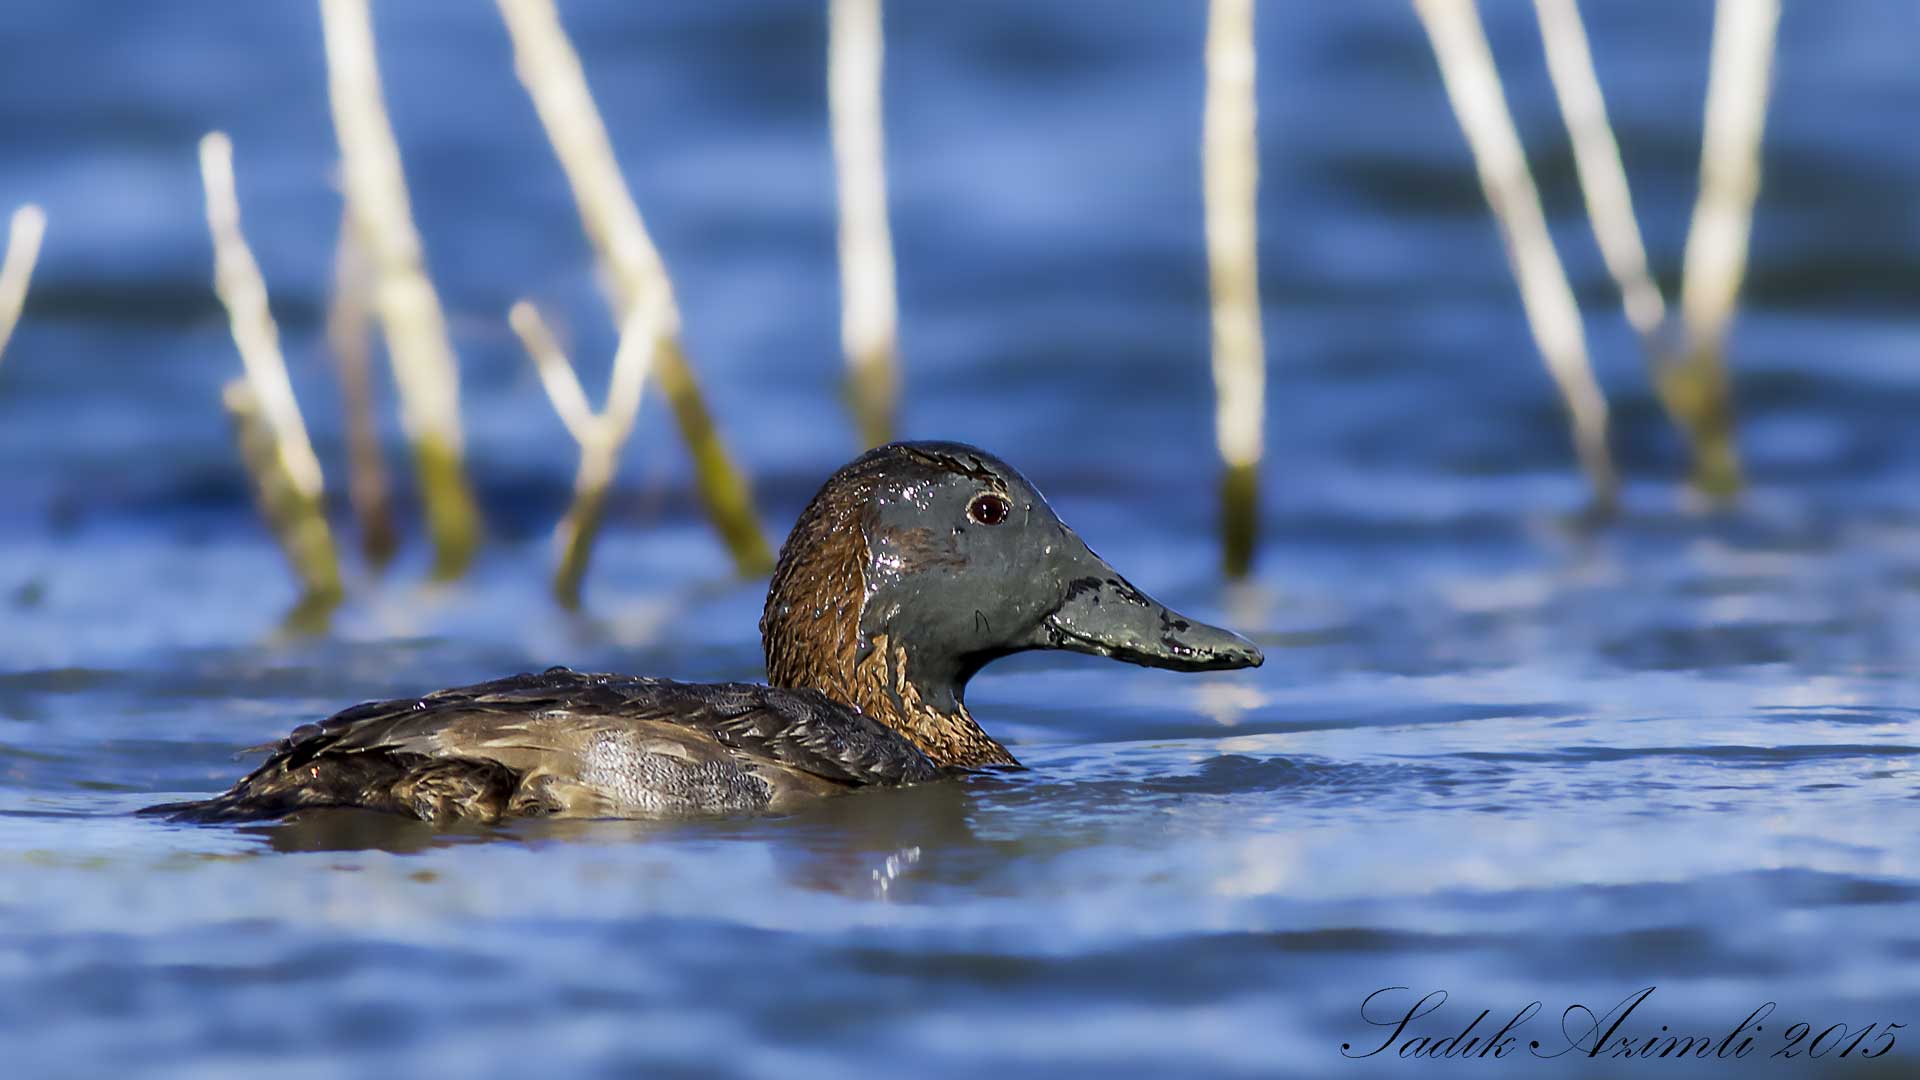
146,442,1263,822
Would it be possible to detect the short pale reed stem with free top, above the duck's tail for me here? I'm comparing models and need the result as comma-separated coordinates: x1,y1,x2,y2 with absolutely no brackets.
200,131,342,605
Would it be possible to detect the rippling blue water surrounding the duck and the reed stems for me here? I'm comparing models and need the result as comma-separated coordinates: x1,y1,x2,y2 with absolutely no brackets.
0,0,1920,1076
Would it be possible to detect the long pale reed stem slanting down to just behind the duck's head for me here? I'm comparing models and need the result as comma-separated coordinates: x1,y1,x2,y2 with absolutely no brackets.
499,0,774,575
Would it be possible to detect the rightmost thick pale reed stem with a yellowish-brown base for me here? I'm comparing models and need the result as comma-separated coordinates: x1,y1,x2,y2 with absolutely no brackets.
1655,0,1780,500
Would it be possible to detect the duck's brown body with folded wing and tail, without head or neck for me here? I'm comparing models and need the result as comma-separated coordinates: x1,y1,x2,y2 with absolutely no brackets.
150,669,947,821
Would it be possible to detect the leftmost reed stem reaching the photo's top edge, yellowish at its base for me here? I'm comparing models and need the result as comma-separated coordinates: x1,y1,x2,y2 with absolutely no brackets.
321,0,480,578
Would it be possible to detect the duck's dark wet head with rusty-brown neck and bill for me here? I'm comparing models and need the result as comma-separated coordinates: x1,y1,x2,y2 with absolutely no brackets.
760,442,1261,767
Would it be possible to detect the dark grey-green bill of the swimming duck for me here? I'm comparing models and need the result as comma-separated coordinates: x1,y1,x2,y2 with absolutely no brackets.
1037,544,1265,671
